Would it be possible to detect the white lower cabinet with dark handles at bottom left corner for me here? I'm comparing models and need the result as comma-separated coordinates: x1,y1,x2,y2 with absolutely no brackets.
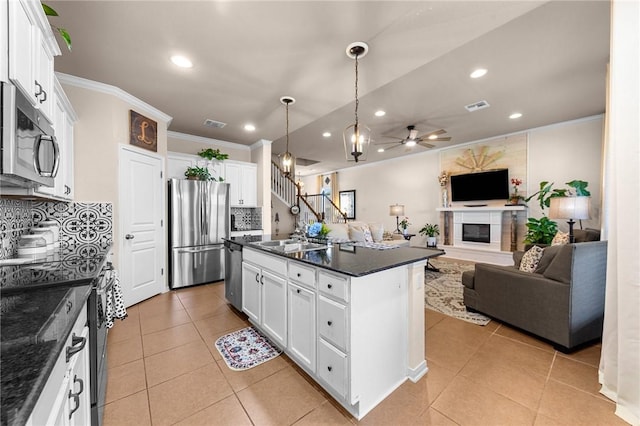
26,304,91,426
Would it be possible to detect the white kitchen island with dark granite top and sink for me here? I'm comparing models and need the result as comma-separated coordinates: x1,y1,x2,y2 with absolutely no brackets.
228,237,444,419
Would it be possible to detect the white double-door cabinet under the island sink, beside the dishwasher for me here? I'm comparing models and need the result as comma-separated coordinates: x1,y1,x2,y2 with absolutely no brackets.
242,248,287,348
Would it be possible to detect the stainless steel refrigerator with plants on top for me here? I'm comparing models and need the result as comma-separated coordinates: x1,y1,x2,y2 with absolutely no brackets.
169,179,230,289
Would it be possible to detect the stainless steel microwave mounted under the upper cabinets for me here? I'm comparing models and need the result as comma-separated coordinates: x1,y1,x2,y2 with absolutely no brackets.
0,83,60,188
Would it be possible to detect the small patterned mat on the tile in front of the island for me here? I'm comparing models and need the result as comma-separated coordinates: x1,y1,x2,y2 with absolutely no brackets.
215,327,282,371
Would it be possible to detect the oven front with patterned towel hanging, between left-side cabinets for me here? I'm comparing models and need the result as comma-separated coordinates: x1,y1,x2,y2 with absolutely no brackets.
88,262,114,426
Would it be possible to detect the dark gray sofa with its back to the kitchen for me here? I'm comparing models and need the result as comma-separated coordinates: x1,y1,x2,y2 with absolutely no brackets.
462,241,607,352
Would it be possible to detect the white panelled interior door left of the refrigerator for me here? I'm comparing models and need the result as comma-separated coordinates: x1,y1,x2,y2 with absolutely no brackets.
118,145,166,306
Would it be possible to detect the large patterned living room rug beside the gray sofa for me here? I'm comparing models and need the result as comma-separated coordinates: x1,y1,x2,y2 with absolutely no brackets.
424,259,491,325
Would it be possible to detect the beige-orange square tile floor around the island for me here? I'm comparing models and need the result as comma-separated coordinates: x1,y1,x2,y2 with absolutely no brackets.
104,283,626,426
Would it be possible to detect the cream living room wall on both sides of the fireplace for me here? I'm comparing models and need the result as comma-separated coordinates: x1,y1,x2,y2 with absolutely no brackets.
303,116,603,241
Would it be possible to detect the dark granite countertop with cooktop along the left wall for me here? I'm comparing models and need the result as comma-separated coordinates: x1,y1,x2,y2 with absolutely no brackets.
0,245,110,425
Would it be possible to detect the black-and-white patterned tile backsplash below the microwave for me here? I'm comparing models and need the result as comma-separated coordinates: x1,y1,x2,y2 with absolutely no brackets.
0,198,113,259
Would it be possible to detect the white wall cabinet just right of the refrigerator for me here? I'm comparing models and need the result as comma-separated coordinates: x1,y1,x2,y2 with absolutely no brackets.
224,161,258,207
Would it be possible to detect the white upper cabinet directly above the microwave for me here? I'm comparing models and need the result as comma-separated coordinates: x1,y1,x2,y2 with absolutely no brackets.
7,0,60,123
